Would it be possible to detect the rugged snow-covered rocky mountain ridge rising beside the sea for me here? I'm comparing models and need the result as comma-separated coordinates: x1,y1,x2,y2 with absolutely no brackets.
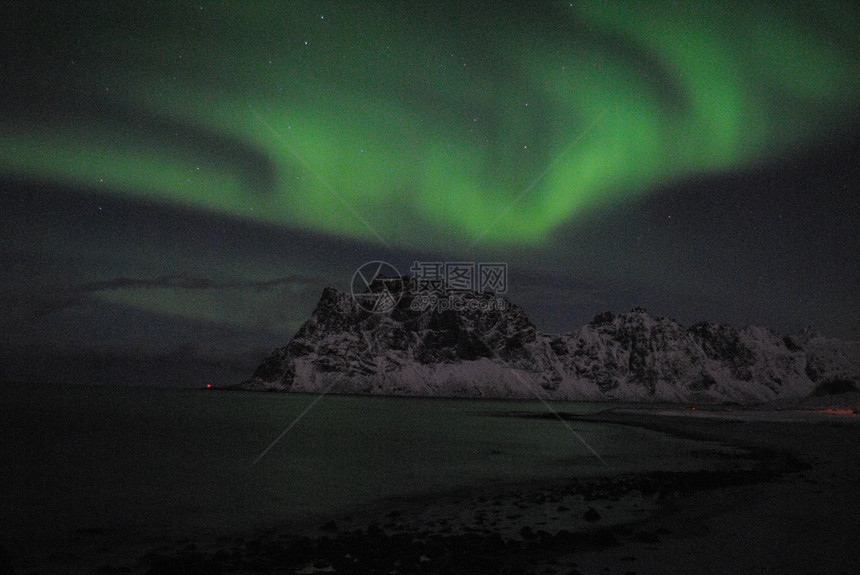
234,278,860,403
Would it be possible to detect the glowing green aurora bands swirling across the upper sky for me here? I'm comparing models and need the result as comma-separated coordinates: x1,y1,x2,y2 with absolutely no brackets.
0,2,860,248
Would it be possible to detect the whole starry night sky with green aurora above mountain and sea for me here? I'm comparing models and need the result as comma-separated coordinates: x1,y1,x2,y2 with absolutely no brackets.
0,0,860,385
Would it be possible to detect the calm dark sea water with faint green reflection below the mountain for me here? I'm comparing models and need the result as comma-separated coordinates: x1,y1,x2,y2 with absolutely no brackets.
0,384,724,568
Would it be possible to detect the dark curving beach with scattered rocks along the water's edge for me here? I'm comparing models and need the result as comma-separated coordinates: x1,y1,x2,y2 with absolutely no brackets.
100,408,860,575
